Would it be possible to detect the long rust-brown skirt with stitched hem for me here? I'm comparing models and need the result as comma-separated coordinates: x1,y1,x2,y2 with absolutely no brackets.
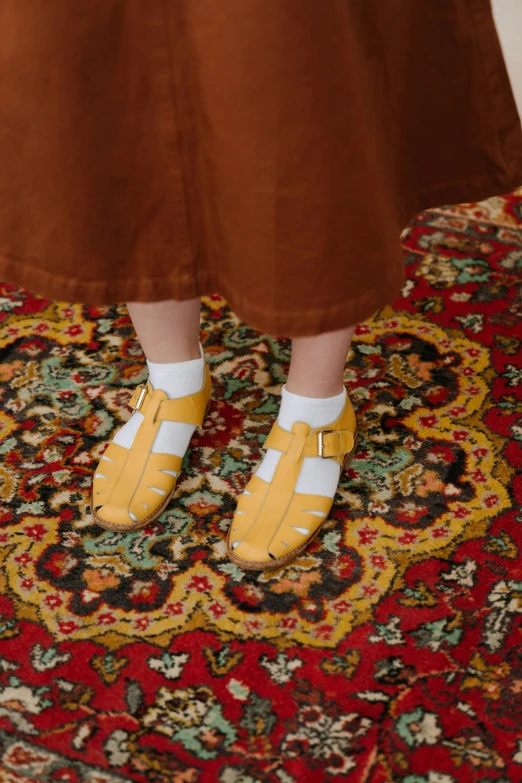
0,0,522,335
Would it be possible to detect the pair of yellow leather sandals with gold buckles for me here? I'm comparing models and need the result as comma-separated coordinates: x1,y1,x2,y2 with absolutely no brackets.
91,365,357,571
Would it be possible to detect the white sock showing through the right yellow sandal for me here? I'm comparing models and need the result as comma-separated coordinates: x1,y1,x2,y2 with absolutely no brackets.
252,386,346,498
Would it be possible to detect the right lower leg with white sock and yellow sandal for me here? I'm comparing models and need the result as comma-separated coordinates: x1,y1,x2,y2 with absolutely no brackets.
228,327,356,570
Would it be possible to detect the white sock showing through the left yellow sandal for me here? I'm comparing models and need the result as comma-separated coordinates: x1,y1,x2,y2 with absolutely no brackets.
113,345,205,457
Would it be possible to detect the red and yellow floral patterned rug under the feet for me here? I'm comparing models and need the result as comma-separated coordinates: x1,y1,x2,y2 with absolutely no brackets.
0,190,522,783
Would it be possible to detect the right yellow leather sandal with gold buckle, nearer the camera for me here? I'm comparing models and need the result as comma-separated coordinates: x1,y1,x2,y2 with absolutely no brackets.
227,395,357,571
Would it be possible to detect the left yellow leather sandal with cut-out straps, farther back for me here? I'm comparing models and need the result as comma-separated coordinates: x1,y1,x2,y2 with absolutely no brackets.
91,364,212,531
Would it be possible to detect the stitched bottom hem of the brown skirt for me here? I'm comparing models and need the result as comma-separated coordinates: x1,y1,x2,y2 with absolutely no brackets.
0,172,522,337
